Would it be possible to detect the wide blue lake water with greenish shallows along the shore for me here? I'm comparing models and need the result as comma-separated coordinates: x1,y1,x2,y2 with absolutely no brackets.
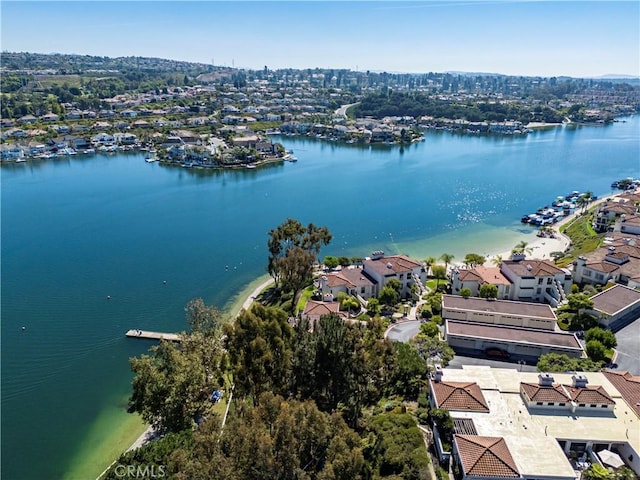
0,116,640,479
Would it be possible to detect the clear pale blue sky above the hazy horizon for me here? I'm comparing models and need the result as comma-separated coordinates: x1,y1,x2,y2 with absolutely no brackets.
0,0,640,77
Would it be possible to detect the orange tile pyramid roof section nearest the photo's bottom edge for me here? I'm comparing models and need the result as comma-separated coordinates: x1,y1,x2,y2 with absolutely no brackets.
454,435,520,478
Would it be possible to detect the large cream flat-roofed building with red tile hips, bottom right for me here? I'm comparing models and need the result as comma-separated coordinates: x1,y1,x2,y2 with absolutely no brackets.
429,365,640,480
